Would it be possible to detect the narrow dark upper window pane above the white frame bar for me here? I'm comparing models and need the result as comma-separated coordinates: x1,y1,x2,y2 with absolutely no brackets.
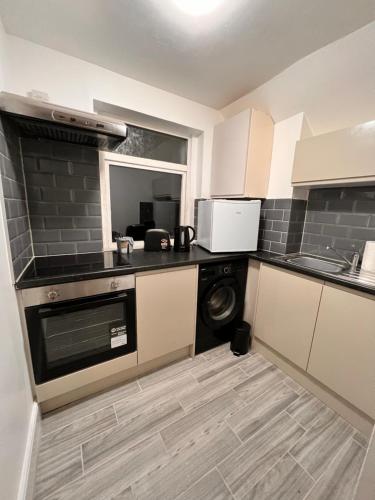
116,125,188,165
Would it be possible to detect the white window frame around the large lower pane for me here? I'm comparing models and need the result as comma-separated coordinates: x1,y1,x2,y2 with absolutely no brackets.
99,148,191,251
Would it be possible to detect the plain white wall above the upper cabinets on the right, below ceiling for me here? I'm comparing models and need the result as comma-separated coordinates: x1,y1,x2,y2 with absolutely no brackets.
221,22,375,134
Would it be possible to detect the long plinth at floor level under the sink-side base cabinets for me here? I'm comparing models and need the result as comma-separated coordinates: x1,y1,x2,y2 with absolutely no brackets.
252,338,374,437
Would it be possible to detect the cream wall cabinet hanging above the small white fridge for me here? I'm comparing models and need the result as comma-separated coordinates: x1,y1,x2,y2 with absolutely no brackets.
211,109,273,198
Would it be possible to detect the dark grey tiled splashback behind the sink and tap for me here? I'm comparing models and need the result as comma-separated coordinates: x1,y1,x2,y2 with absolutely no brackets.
301,186,375,257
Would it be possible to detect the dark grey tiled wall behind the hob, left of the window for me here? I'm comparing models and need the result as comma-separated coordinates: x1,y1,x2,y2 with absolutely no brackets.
22,139,103,255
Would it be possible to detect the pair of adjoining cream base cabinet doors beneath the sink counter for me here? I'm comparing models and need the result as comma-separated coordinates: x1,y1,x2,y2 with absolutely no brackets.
253,263,375,419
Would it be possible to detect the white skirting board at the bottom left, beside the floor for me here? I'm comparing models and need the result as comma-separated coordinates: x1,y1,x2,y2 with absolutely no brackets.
17,401,41,500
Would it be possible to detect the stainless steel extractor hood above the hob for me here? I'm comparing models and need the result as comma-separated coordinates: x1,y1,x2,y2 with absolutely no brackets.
0,92,127,150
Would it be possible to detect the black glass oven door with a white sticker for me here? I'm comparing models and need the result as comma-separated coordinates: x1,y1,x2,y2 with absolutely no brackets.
25,290,137,384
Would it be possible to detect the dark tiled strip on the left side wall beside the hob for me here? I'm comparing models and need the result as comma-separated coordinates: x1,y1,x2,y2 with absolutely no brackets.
0,117,33,278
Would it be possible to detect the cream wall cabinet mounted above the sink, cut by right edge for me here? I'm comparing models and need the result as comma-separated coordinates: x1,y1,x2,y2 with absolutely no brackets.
292,122,375,186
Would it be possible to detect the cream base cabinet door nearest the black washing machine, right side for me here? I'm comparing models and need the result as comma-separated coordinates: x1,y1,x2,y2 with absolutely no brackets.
254,264,323,370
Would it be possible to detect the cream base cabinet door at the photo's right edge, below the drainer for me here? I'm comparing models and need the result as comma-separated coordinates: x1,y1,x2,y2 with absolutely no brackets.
307,285,375,418
